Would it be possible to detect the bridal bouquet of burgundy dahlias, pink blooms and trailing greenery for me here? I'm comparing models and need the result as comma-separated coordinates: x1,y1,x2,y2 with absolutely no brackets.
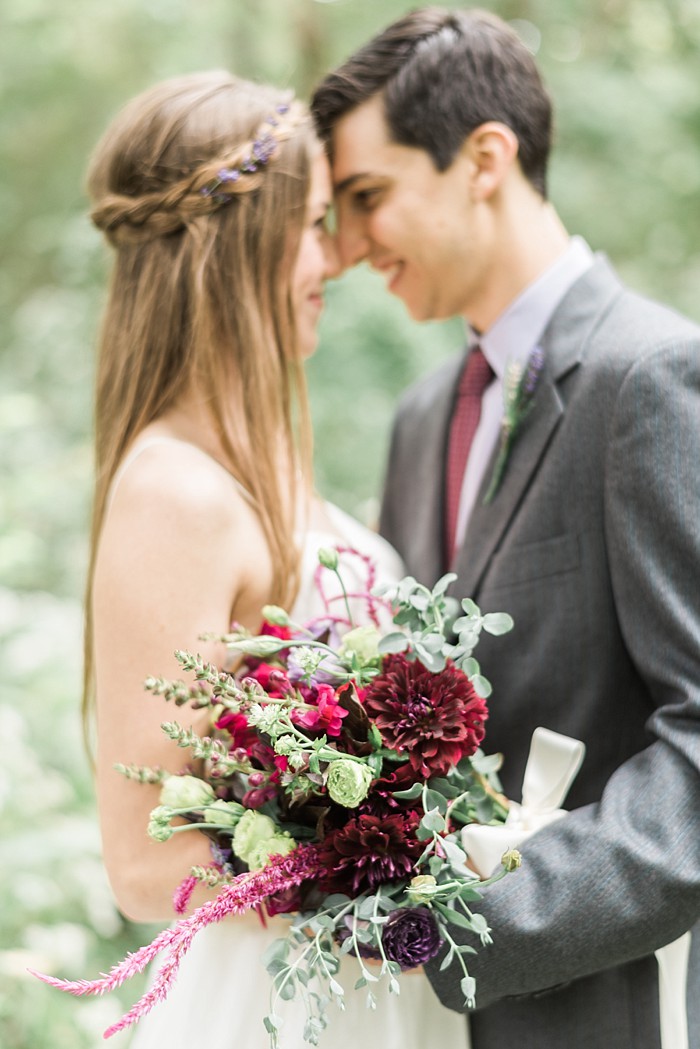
36,549,519,1046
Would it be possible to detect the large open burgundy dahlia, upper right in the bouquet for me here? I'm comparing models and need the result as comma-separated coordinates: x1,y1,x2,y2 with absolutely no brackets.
364,655,488,778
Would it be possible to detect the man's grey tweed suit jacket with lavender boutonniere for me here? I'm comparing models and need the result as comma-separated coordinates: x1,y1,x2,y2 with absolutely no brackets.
382,258,700,1049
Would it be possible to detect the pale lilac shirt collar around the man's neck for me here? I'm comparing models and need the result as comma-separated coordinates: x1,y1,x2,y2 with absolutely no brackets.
470,237,594,379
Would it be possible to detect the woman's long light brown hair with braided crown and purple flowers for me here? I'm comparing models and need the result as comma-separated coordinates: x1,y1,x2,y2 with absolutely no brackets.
83,72,318,737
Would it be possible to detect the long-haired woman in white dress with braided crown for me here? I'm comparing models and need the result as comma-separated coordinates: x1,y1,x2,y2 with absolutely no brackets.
84,72,466,1049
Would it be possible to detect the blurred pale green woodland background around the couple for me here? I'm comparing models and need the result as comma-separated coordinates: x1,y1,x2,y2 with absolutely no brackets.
0,0,700,1049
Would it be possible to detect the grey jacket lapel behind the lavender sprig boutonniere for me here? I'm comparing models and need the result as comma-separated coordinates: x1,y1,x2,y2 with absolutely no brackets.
454,257,620,595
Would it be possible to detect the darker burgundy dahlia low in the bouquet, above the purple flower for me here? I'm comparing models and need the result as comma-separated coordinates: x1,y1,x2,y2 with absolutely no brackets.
319,812,424,896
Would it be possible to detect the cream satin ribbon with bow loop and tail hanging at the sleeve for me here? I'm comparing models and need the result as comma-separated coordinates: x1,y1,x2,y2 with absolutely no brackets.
462,728,691,1049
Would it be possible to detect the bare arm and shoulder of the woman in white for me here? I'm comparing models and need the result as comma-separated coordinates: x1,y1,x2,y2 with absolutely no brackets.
93,448,270,921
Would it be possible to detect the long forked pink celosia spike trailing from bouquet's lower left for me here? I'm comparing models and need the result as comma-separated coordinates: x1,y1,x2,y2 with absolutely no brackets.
29,845,322,1037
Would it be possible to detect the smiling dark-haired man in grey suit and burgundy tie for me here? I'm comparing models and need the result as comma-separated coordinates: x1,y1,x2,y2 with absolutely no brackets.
313,7,700,1049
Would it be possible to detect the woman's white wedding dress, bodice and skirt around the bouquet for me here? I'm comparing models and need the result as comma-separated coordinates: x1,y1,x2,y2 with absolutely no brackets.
131,506,468,1049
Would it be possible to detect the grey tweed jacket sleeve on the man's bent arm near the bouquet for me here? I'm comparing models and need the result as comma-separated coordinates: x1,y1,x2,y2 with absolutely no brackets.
426,341,700,1011
